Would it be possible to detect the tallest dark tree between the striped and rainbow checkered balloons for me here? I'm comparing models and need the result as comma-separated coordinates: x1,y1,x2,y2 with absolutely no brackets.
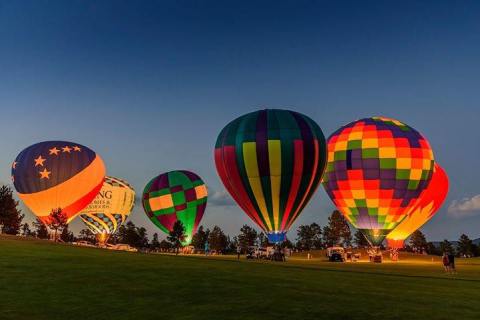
323,210,352,247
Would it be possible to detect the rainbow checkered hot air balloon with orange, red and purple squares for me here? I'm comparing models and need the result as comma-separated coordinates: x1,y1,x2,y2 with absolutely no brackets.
323,117,434,247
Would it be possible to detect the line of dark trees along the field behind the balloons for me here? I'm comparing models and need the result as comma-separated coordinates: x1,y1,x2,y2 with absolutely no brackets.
0,186,480,257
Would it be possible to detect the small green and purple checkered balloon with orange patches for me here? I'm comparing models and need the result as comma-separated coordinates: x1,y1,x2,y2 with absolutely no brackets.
142,170,207,246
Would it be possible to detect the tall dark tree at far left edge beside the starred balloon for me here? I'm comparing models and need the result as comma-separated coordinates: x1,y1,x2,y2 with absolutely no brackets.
0,186,24,235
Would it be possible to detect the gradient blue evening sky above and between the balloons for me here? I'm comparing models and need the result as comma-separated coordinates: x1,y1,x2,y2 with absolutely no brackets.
0,0,480,240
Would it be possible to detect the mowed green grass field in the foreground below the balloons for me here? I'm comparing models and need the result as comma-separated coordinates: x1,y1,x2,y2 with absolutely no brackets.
0,237,480,320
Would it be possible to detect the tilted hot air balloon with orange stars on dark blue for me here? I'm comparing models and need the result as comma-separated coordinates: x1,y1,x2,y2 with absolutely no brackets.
12,141,105,223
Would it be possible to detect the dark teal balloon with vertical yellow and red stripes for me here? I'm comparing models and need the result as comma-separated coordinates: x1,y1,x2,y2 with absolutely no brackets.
215,109,326,243
